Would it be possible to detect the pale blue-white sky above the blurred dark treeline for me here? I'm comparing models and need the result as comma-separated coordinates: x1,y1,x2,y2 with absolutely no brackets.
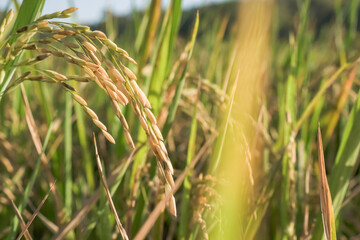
0,0,228,24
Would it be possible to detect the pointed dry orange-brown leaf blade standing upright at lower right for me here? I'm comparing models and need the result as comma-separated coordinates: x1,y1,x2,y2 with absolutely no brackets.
317,124,336,240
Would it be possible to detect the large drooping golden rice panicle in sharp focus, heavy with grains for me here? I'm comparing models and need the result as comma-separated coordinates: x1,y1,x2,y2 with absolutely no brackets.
0,8,176,215
